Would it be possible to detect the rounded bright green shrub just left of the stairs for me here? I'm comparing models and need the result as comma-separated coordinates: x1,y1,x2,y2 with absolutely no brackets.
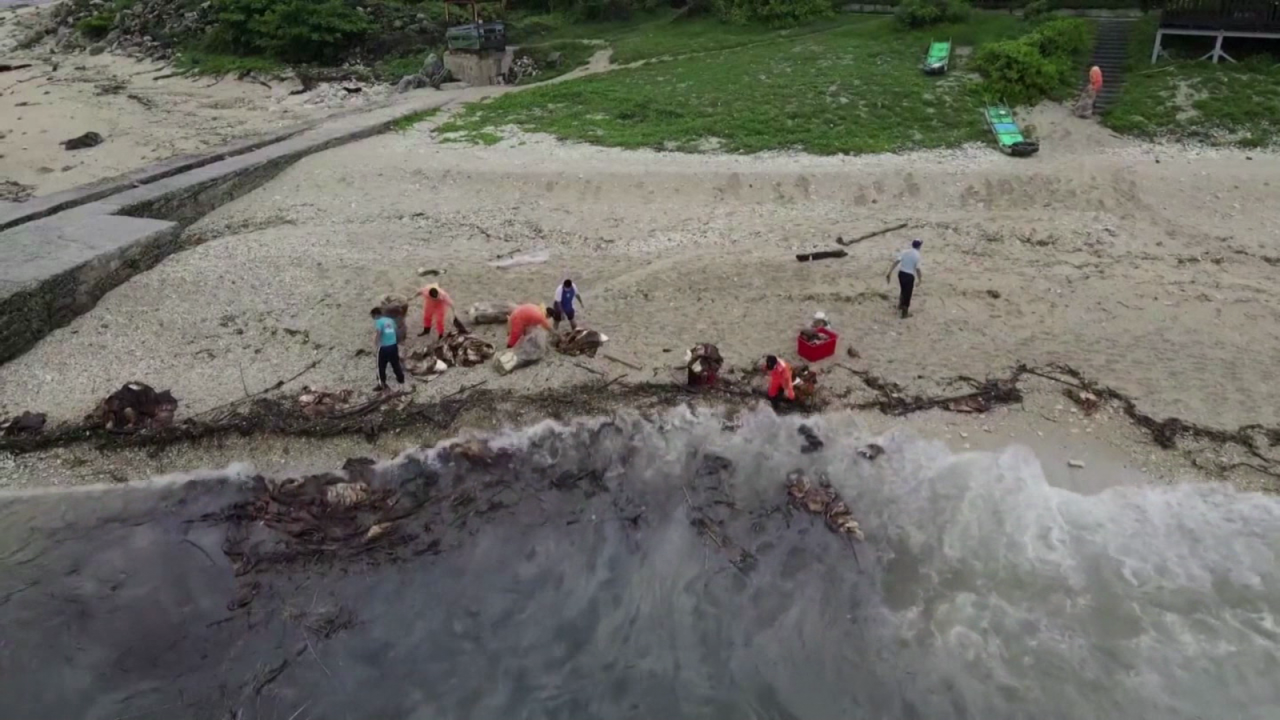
974,18,1092,105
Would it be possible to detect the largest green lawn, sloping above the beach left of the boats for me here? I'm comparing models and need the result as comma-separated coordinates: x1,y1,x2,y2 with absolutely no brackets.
438,13,1027,154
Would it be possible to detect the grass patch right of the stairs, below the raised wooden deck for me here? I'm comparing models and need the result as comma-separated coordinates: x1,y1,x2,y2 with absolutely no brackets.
1103,18,1280,147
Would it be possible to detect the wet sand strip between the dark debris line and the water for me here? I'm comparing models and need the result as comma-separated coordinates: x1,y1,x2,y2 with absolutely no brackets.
0,368,1249,495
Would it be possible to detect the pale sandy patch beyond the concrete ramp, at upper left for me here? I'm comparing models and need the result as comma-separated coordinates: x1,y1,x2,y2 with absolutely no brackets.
0,2,390,200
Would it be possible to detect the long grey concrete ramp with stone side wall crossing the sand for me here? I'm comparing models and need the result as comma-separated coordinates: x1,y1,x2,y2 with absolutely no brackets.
0,91,461,363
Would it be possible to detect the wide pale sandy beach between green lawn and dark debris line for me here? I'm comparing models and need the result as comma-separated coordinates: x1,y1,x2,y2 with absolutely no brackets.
0,96,1280,487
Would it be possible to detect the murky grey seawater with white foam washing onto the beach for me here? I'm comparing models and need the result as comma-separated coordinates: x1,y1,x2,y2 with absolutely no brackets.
0,410,1280,720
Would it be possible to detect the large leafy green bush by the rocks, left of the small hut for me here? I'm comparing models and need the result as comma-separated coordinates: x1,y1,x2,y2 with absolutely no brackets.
214,0,372,63
